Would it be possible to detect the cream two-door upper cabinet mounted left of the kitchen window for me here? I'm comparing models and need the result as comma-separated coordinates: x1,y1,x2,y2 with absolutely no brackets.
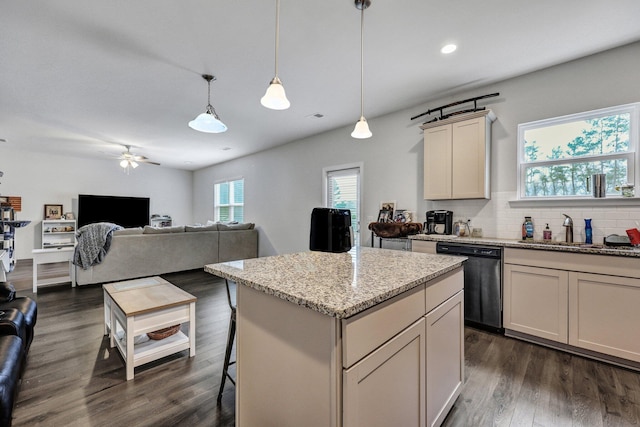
421,110,496,200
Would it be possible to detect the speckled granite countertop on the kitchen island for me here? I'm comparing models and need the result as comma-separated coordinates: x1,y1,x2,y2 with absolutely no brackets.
204,247,466,318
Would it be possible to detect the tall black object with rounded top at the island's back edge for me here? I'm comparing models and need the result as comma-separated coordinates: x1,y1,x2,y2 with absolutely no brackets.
309,208,353,252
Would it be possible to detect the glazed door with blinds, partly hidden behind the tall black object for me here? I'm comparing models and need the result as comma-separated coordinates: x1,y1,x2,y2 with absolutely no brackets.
324,167,360,245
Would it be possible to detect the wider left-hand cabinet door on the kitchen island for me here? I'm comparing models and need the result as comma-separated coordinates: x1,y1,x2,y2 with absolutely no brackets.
343,318,426,427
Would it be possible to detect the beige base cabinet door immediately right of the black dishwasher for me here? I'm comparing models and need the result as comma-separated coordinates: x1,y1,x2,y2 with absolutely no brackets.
503,264,569,344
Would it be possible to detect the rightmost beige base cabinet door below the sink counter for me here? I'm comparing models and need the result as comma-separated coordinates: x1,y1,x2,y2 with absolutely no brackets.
569,273,640,362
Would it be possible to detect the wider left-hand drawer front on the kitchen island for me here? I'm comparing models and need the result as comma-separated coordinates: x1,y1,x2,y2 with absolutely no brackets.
342,285,425,368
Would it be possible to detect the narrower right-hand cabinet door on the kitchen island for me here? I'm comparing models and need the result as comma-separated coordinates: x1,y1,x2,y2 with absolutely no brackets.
428,291,464,426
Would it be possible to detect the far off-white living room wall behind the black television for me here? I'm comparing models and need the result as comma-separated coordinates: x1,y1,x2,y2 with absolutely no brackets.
0,148,193,259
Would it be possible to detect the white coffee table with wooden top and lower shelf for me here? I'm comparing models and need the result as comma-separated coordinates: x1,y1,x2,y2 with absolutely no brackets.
102,277,197,381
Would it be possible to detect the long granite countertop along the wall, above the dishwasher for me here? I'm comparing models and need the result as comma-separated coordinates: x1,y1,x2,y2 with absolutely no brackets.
409,234,640,258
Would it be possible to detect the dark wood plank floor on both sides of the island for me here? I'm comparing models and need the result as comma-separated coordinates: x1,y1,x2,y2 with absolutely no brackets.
3,264,640,427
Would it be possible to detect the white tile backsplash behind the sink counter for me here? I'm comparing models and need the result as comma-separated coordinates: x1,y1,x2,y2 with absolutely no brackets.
429,192,640,243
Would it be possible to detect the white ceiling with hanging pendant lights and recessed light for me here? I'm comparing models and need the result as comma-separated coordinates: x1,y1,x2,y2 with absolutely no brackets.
0,0,640,170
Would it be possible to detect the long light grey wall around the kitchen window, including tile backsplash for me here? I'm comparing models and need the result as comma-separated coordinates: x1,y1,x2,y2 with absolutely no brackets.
194,43,640,256
